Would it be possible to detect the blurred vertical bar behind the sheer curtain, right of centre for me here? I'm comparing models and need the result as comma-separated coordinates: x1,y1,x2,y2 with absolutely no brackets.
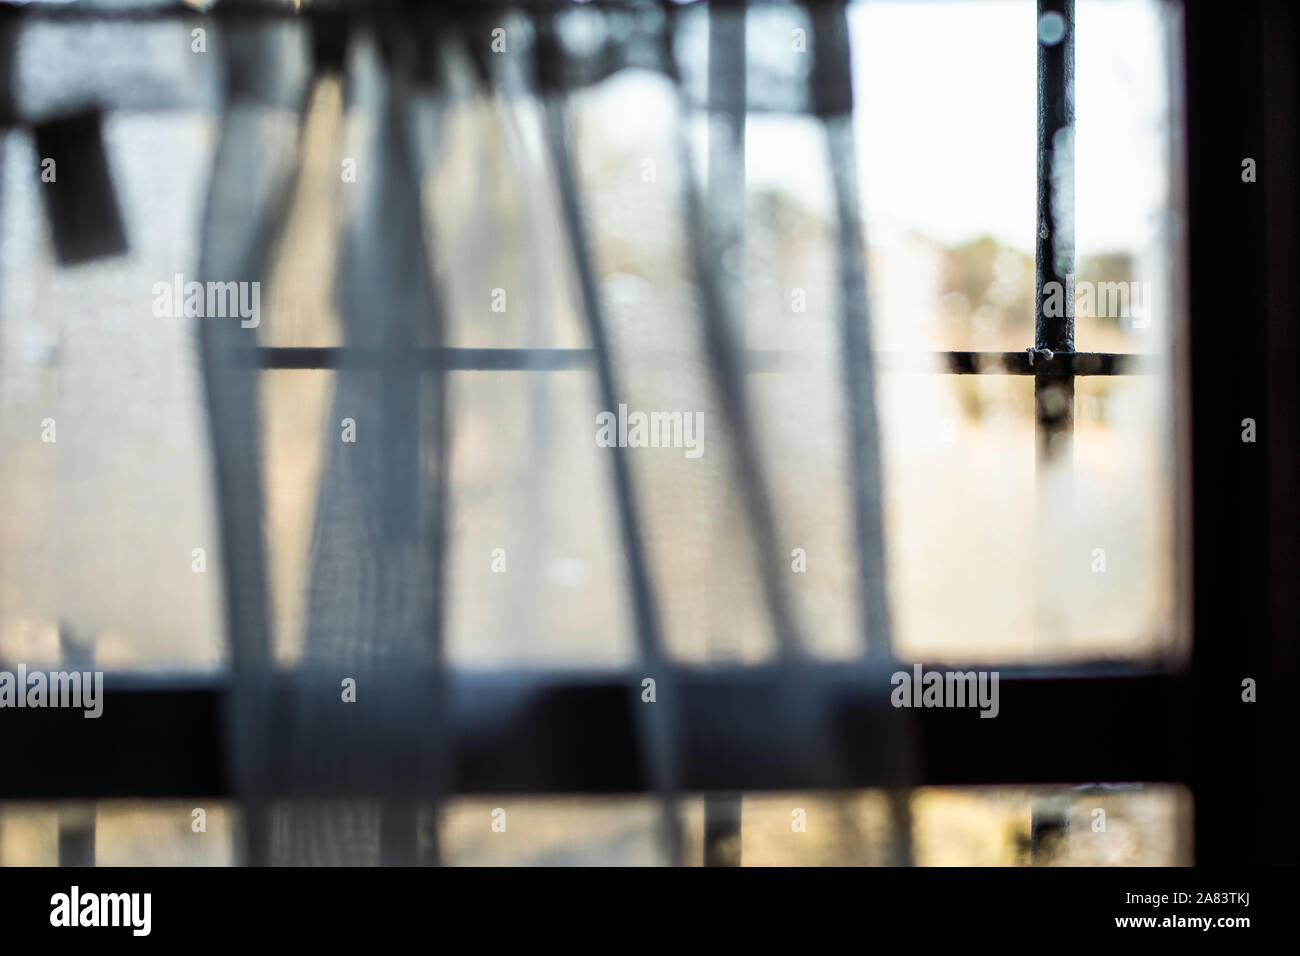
705,4,746,866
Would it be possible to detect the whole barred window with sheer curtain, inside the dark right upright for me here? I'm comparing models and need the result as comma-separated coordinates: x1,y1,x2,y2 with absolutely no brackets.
0,0,1289,864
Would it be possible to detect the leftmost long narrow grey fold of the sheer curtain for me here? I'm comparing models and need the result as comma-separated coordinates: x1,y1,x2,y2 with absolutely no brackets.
198,14,307,864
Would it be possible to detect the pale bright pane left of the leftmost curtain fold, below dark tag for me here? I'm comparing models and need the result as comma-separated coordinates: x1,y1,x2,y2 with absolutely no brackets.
0,111,222,669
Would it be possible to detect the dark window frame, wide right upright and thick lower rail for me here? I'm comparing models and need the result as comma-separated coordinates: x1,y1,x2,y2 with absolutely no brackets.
0,0,1300,864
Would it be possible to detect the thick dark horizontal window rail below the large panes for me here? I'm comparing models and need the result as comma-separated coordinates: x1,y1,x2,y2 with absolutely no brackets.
0,665,1187,800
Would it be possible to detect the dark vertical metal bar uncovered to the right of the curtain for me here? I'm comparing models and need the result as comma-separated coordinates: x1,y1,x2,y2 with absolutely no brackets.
1030,0,1075,862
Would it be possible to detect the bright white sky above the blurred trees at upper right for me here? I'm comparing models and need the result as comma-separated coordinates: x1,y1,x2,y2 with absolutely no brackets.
593,0,1173,255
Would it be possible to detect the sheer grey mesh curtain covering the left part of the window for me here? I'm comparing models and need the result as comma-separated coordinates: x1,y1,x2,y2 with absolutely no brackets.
0,1,891,864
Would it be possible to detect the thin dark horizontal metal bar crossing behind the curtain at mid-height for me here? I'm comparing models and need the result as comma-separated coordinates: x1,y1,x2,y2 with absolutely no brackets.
243,346,1156,376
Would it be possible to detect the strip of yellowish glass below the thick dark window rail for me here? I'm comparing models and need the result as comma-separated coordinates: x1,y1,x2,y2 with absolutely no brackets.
0,784,1192,866
